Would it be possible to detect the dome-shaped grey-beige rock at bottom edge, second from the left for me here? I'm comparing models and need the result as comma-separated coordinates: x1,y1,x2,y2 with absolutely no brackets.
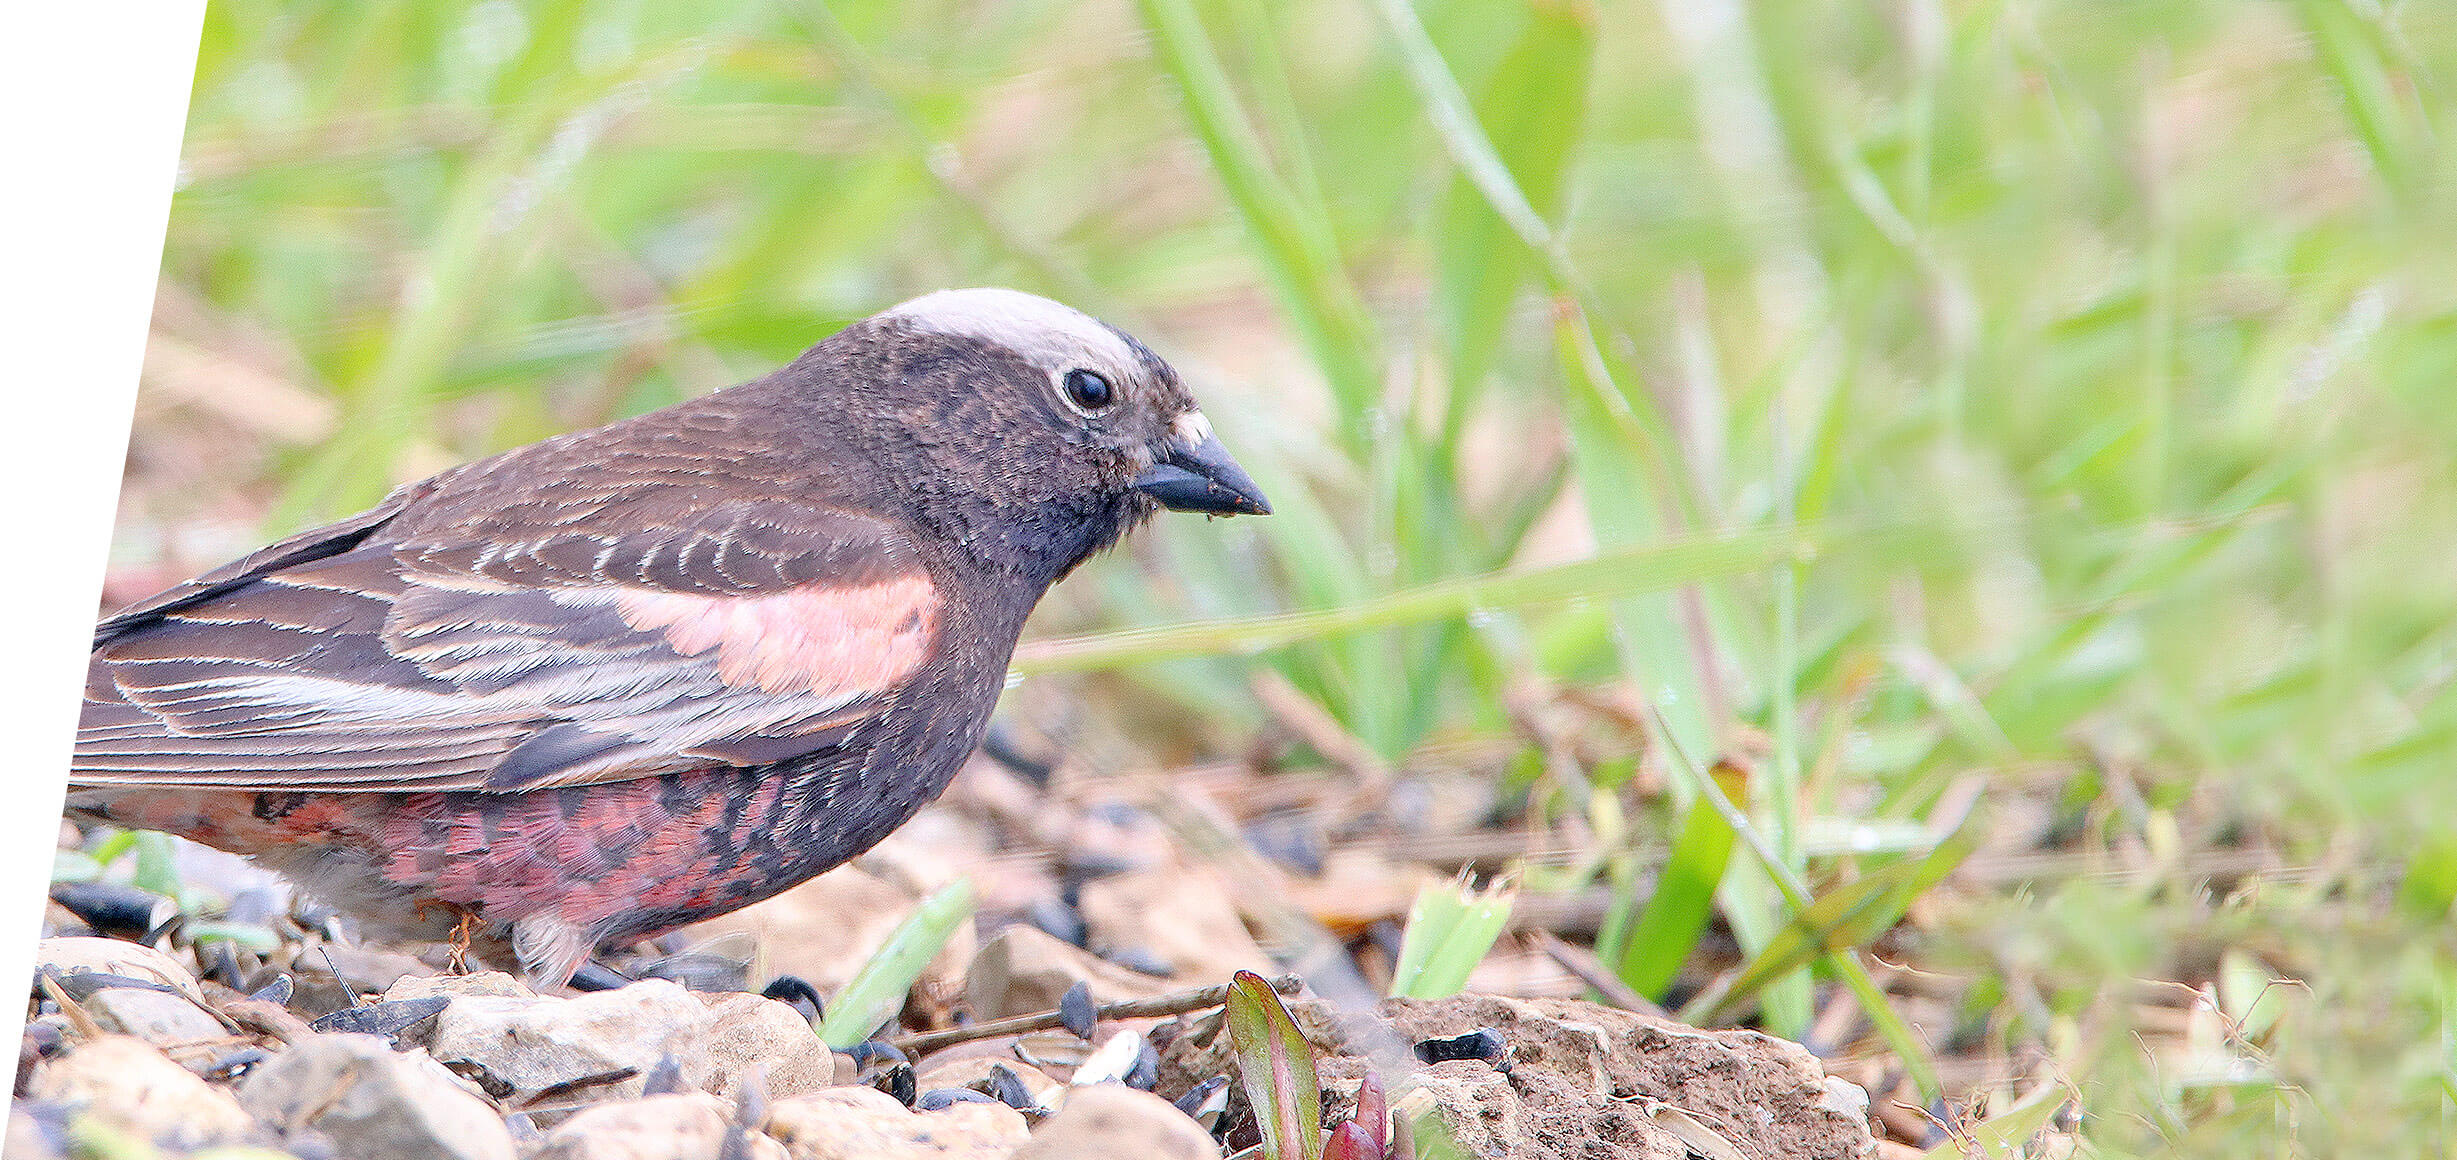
238,1035,514,1160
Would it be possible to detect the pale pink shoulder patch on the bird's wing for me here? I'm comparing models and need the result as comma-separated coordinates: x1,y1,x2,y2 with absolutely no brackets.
614,573,939,698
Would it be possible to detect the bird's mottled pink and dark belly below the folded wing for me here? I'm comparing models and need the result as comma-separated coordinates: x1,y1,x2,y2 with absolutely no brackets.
69,752,946,944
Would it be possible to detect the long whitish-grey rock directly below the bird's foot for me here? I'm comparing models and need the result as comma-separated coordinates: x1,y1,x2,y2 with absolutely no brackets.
430,978,717,1108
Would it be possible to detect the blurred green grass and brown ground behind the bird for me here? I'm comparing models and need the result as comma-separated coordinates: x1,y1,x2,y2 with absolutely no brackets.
90,0,2457,1155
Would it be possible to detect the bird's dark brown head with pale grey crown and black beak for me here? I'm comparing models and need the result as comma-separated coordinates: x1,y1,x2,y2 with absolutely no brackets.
806,290,1270,580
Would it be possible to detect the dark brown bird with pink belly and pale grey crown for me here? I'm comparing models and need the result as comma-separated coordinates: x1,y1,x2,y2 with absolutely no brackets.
66,288,1270,986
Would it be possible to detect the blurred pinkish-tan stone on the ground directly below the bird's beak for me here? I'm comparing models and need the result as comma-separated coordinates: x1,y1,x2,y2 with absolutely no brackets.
1084,865,1273,981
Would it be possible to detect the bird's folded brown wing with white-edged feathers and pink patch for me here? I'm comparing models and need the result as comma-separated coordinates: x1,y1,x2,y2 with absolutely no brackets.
74,499,939,791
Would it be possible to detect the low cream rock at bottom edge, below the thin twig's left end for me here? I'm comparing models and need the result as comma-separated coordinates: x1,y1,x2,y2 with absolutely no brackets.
767,1086,1029,1160
